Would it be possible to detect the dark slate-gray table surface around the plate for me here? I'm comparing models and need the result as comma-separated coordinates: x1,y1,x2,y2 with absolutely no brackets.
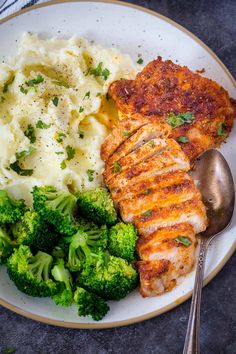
0,0,236,354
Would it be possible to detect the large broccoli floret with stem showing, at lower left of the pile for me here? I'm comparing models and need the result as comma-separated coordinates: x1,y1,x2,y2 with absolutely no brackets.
7,245,60,297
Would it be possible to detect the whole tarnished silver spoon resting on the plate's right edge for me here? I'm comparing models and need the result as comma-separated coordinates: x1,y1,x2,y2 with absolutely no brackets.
183,149,235,354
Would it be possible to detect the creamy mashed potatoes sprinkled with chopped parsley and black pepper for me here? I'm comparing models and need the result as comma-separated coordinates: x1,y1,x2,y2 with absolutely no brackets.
0,34,137,204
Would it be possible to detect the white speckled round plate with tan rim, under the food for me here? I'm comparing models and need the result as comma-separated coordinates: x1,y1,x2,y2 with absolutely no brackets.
0,1,236,328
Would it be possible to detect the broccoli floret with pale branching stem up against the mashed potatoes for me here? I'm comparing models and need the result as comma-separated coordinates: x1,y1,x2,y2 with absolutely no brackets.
32,186,77,236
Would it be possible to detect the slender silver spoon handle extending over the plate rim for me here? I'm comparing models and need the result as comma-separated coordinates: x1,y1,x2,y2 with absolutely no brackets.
183,238,208,354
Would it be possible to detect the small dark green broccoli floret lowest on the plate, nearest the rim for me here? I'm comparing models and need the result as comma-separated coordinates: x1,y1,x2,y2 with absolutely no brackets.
74,287,109,321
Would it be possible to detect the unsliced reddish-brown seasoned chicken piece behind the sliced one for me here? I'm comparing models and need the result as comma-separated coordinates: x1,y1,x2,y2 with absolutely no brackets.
109,57,236,160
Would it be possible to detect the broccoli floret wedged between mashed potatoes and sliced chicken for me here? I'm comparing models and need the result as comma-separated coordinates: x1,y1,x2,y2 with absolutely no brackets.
77,187,117,225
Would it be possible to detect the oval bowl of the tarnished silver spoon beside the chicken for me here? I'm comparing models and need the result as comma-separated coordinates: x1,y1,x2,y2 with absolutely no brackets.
191,149,235,238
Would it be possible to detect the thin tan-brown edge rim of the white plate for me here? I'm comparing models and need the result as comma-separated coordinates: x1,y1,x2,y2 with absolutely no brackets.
0,0,236,329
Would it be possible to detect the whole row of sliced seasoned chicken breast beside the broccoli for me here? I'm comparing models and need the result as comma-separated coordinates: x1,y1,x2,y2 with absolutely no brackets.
101,115,207,296
